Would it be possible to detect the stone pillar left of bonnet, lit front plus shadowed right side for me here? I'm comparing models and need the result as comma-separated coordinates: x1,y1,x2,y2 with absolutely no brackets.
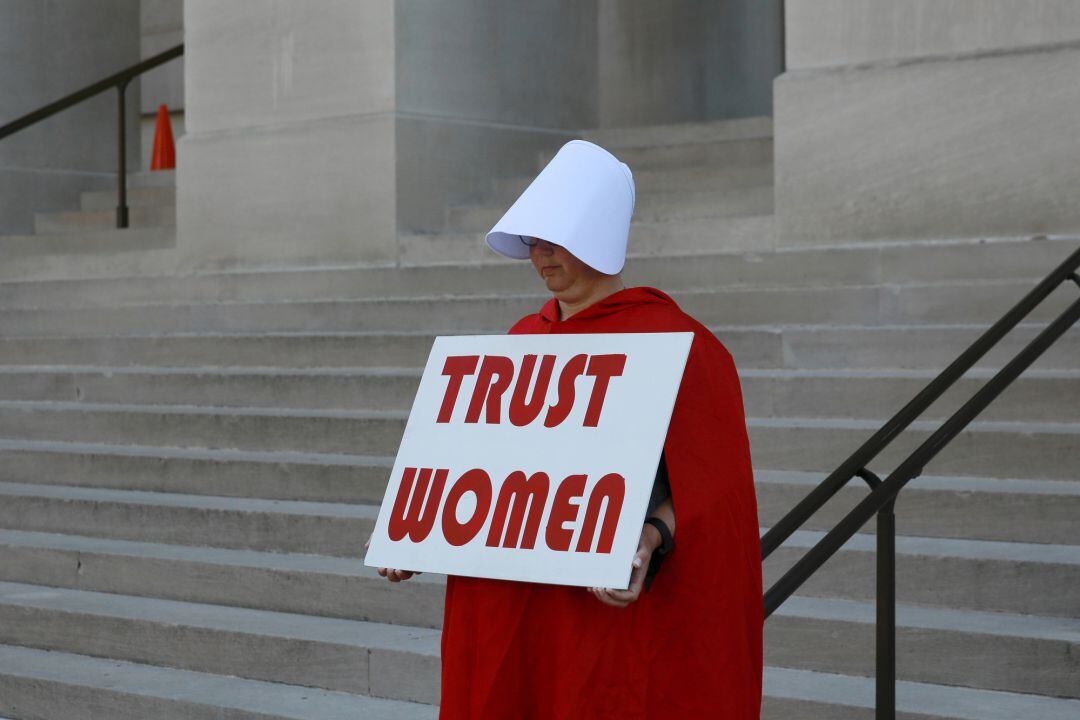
177,0,595,268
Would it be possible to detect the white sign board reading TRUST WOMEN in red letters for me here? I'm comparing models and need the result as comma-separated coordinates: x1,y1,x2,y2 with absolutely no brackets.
365,332,693,588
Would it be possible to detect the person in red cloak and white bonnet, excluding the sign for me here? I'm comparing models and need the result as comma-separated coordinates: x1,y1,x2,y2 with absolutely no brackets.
379,140,764,720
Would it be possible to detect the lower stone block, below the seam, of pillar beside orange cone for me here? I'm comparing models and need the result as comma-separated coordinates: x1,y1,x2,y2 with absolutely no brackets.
177,112,397,269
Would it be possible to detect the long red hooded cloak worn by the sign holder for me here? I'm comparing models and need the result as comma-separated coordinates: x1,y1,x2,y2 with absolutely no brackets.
440,287,764,720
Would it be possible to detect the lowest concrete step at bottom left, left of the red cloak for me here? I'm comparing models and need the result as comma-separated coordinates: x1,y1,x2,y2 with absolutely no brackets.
0,646,438,720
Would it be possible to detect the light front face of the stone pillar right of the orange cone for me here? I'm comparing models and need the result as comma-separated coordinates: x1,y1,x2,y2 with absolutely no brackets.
177,0,396,268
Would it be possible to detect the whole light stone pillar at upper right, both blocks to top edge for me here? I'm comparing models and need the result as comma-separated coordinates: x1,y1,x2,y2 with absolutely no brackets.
774,0,1080,245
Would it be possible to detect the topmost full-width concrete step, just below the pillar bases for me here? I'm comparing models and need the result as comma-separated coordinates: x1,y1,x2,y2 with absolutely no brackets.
0,239,1080,308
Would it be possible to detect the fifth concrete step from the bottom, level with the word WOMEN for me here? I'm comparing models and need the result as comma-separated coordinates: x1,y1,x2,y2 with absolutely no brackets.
0,439,1080,544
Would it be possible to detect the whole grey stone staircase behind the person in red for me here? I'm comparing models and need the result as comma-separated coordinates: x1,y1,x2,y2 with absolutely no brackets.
0,120,1080,720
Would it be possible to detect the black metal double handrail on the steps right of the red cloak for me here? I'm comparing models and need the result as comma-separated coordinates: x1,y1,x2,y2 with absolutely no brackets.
761,243,1080,720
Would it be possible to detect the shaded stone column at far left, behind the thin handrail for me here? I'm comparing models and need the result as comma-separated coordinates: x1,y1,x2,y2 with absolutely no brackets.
0,0,139,234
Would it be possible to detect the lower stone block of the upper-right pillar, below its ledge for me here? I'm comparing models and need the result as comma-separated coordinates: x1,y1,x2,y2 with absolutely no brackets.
775,45,1080,245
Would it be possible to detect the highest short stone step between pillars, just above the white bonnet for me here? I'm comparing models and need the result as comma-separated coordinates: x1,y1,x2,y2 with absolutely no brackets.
580,116,772,148
